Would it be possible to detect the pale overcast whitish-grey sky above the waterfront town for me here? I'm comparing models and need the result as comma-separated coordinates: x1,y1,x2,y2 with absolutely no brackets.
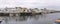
0,0,60,10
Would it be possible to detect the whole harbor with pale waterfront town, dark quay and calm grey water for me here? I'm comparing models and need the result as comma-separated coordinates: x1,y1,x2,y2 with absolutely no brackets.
0,7,60,24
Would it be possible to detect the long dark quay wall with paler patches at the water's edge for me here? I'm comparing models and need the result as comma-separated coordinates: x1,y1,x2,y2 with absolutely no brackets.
0,13,41,16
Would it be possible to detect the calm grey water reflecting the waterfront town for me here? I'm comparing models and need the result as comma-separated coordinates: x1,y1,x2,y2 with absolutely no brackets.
2,13,60,24
